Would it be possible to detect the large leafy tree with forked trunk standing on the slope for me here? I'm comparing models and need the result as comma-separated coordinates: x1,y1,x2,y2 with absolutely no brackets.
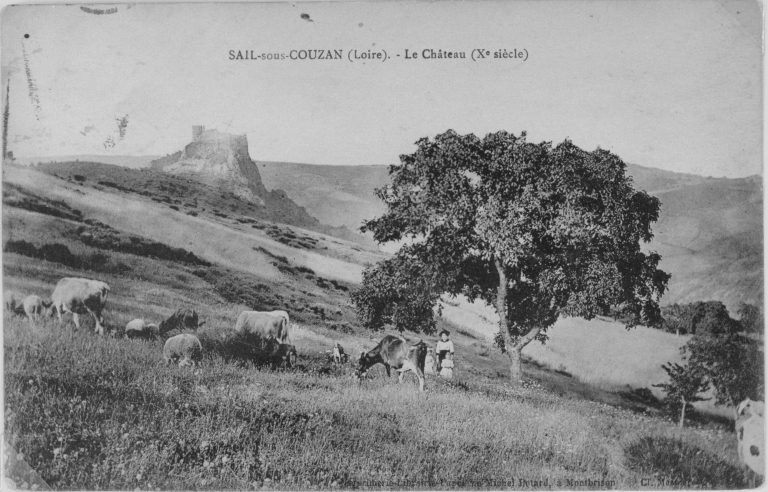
353,130,669,382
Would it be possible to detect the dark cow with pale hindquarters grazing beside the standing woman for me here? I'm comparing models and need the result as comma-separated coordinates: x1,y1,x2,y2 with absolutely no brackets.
357,335,427,391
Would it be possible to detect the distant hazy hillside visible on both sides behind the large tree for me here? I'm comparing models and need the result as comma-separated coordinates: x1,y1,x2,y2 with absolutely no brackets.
258,162,763,313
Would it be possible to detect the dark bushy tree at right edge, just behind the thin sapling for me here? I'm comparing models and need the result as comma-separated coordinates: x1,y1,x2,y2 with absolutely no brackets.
680,335,765,418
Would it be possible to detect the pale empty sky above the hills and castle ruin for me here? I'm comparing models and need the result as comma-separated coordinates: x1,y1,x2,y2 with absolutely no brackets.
2,0,763,177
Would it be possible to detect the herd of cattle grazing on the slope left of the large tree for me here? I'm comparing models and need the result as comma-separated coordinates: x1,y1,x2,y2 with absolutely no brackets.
4,277,427,391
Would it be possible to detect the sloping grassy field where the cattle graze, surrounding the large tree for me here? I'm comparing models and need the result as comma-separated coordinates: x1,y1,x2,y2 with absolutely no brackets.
3,168,746,490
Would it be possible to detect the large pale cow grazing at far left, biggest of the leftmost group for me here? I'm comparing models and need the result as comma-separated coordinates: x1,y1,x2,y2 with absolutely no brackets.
51,277,109,335
